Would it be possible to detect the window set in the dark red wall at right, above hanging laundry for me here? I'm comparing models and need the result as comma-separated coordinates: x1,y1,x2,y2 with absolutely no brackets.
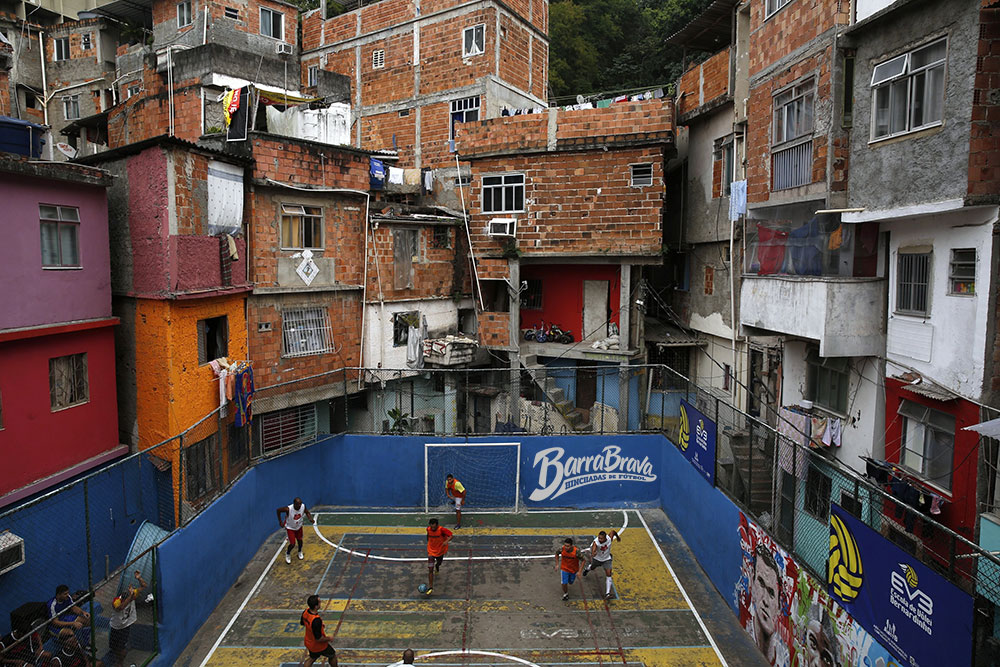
899,399,955,490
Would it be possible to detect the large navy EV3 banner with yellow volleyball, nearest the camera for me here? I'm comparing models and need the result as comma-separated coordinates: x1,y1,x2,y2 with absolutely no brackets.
827,504,972,667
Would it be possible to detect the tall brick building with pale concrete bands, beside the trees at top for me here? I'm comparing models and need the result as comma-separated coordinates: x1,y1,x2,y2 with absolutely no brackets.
302,0,549,178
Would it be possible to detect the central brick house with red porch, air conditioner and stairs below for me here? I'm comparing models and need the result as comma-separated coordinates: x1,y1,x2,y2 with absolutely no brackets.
458,100,673,430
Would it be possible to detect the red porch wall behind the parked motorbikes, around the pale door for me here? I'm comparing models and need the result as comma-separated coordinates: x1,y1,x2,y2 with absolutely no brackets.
521,264,621,340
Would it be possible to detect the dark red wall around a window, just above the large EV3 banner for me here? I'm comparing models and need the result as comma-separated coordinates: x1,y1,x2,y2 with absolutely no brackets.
885,378,980,540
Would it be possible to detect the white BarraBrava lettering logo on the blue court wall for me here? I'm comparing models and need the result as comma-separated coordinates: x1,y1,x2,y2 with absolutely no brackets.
528,445,656,501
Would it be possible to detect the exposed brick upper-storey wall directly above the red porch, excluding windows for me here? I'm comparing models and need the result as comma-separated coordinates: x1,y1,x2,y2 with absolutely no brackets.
469,145,665,257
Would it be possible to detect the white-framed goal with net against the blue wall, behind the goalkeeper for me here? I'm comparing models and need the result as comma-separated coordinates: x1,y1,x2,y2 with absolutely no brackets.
424,442,521,512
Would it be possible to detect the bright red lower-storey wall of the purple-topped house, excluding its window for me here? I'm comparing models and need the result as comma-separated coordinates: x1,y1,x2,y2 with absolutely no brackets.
0,326,118,497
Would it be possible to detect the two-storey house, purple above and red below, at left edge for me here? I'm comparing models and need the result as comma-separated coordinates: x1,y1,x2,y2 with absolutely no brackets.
0,153,128,507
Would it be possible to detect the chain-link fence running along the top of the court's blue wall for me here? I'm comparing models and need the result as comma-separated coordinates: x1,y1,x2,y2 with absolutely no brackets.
0,359,1000,664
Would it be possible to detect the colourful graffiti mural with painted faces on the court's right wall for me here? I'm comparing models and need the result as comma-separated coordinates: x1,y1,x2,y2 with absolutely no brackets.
733,512,900,667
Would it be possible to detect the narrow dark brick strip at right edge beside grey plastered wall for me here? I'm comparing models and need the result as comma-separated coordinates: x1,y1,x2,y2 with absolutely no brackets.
969,0,1000,198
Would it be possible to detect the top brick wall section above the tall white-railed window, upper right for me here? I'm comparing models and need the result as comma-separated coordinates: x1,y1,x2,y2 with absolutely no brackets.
749,0,851,78
